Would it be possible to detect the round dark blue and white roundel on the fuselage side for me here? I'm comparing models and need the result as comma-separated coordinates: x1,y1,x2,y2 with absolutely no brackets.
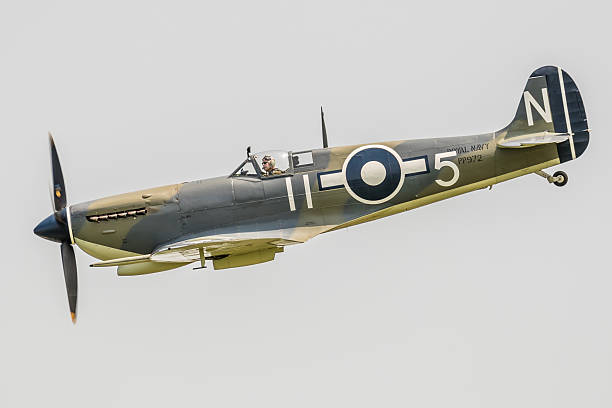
342,145,404,204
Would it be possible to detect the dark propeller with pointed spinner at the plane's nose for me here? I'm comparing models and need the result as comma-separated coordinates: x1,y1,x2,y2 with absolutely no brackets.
34,133,78,323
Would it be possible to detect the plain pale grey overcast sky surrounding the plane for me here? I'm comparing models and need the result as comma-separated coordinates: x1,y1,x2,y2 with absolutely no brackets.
0,0,612,408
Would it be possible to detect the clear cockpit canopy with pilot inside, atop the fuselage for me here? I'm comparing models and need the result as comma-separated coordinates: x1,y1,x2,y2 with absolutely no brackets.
232,150,313,177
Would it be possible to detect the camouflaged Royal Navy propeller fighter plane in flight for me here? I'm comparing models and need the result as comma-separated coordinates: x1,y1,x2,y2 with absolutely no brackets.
34,66,589,322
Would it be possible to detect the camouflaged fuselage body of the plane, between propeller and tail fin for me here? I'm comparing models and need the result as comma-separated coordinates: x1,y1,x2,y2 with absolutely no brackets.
69,133,559,260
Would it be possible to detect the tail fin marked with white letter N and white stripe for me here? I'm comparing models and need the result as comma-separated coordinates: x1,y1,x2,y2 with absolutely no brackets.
499,66,589,162
